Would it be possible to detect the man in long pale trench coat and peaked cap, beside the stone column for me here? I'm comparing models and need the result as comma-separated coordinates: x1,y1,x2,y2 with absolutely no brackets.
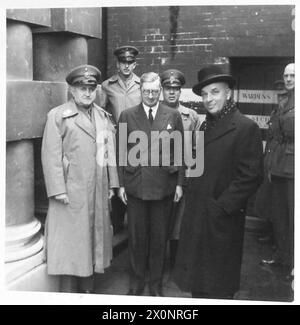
42,65,119,293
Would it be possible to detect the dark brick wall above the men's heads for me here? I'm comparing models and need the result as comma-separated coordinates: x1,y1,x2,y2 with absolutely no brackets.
107,5,295,87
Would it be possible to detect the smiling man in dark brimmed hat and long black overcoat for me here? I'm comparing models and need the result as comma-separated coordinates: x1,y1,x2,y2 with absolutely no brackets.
174,65,263,299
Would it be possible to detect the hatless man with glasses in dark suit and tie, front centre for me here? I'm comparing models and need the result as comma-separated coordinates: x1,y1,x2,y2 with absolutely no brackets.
117,72,184,296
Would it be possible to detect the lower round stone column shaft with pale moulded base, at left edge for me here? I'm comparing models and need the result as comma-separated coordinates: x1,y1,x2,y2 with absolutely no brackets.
5,140,43,263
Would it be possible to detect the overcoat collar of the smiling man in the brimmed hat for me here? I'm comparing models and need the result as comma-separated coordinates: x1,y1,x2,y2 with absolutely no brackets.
204,109,238,145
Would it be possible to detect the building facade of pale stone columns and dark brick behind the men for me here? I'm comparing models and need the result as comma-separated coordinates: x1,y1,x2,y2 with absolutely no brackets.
5,5,295,291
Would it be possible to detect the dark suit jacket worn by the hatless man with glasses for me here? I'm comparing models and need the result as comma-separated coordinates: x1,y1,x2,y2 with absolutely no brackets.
117,104,185,200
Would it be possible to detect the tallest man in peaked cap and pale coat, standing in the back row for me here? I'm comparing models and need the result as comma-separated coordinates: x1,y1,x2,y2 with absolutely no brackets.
100,45,142,233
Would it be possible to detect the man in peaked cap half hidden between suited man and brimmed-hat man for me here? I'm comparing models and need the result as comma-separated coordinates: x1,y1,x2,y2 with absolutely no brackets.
160,69,201,266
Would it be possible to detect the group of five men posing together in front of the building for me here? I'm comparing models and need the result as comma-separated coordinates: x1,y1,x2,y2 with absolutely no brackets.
42,46,294,298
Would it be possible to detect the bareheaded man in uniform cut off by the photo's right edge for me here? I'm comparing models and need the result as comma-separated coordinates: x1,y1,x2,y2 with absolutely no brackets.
261,63,295,275
